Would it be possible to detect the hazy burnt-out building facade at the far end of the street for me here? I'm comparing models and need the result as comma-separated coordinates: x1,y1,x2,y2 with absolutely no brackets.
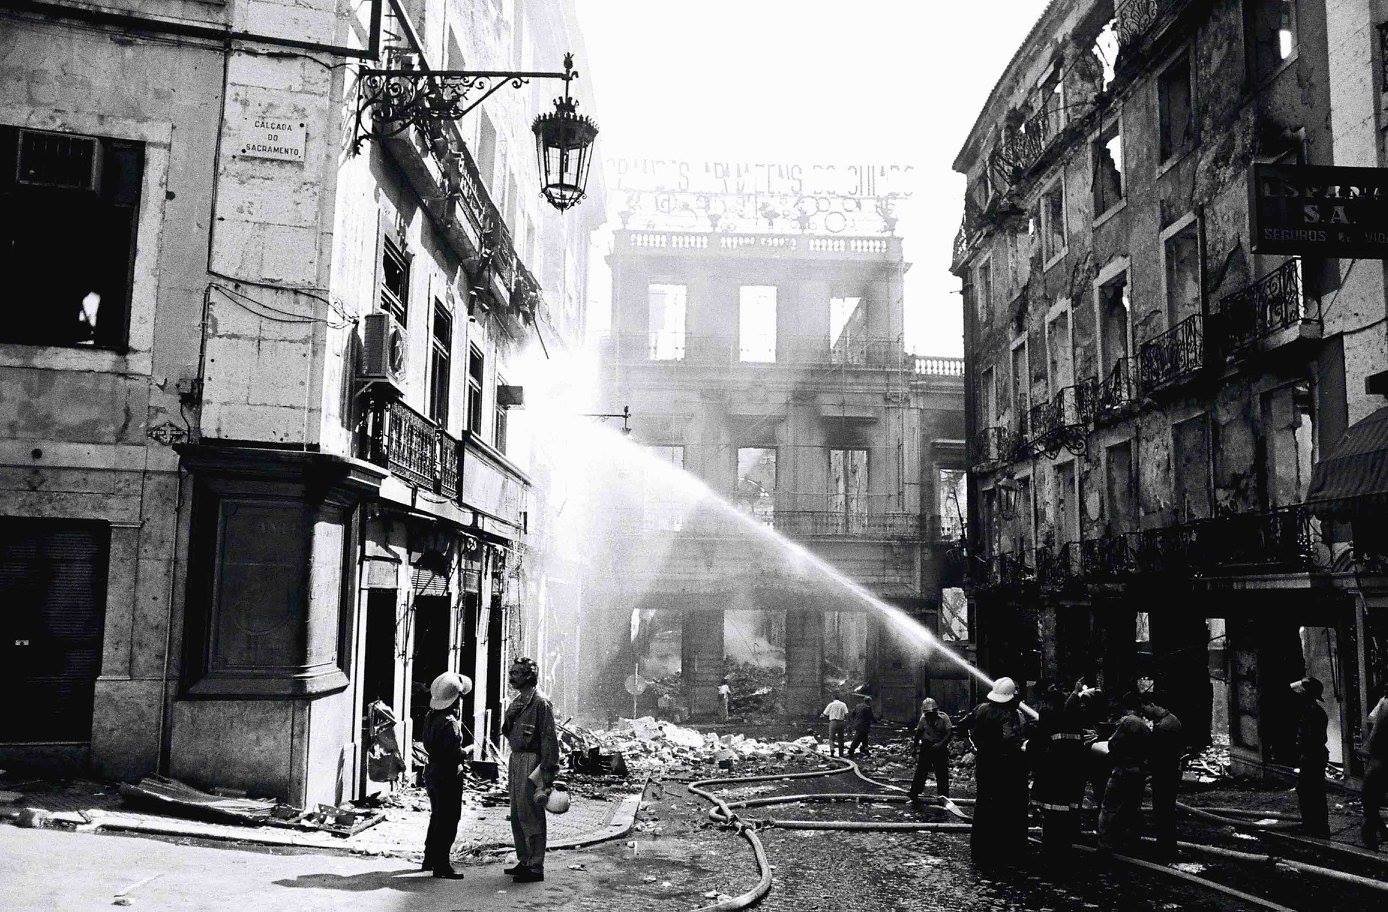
602,223,967,719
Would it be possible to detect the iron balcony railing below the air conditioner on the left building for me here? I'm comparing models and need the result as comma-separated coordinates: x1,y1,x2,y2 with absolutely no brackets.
361,401,459,500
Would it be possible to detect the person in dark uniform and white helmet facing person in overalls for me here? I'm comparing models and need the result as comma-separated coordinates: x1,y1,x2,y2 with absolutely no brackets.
421,672,472,880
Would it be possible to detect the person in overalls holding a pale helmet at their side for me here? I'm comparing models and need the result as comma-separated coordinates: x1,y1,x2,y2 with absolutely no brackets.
501,658,559,883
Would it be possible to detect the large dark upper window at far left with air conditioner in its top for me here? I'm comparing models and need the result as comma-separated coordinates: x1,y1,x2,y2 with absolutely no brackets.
0,126,144,348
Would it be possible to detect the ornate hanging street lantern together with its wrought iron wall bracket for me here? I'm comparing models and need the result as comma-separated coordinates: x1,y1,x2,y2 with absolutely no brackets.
351,54,598,211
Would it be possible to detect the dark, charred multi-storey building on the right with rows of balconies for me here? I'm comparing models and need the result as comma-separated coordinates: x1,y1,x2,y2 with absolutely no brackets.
954,0,1385,776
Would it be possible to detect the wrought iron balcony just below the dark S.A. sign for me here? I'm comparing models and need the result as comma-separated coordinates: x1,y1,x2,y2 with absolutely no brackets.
1212,258,1321,355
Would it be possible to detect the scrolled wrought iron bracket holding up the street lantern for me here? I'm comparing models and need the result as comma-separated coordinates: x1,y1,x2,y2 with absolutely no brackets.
351,54,579,154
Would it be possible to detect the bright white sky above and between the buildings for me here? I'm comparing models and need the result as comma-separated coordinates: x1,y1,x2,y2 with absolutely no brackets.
575,0,1045,355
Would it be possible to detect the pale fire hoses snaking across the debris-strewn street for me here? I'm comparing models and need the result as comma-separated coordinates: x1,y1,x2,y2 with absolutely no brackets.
688,758,1388,912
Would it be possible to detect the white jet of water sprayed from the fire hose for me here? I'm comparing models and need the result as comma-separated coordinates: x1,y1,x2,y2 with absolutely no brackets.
505,340,1035,718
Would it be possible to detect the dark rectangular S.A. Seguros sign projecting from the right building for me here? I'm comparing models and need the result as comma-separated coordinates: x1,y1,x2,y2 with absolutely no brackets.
1248,164,1388,260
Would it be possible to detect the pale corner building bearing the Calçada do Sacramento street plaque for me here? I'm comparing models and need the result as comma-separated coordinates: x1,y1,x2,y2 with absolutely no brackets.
0,0,602,805
